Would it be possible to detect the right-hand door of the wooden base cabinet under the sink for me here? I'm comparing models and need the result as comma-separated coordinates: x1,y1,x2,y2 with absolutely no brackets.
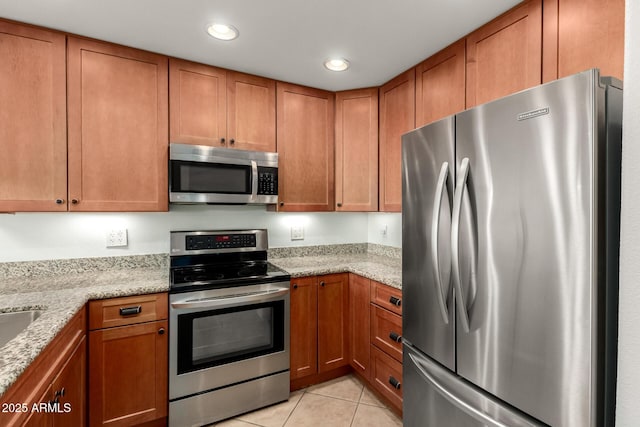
51,337,87,427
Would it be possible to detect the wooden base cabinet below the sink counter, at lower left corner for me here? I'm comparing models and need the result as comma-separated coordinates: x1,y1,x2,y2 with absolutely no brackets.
0,308,87,427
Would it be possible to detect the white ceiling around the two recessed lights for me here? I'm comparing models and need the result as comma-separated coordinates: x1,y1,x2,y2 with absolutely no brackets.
0,0,520,91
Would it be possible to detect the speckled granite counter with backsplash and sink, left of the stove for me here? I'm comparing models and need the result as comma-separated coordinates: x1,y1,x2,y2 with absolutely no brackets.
0,255,169,396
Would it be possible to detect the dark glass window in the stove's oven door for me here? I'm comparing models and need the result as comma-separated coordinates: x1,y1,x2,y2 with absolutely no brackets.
178,301,284,374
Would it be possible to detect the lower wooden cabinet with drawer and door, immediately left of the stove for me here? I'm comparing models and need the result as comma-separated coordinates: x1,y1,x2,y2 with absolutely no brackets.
89,294,169,427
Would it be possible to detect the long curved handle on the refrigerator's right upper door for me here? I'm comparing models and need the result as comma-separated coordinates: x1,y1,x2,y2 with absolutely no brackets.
451,157,469,333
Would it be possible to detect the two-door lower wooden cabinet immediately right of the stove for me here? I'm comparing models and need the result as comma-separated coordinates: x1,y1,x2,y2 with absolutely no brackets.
291,273,349,389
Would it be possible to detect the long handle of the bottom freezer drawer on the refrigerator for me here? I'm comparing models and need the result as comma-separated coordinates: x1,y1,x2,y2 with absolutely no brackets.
408,352,543,427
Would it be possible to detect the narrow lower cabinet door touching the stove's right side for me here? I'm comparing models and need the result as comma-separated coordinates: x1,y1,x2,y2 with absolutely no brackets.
290,276,318,380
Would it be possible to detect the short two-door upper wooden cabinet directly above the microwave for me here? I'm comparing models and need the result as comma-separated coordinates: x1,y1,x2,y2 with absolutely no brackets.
169,58,276,151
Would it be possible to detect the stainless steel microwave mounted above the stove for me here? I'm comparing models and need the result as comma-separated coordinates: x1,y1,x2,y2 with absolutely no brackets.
169,144,278,204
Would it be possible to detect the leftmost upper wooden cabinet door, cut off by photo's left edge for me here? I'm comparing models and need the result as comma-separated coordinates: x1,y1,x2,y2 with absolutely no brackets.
0,21,67,212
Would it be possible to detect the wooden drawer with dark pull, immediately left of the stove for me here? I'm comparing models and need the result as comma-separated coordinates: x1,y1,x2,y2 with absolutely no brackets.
89,293,169,330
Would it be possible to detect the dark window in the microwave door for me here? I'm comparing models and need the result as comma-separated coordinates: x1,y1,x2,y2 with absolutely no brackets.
171,160,251,194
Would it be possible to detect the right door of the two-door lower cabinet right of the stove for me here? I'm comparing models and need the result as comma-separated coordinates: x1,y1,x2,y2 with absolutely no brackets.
318,274,349,373
